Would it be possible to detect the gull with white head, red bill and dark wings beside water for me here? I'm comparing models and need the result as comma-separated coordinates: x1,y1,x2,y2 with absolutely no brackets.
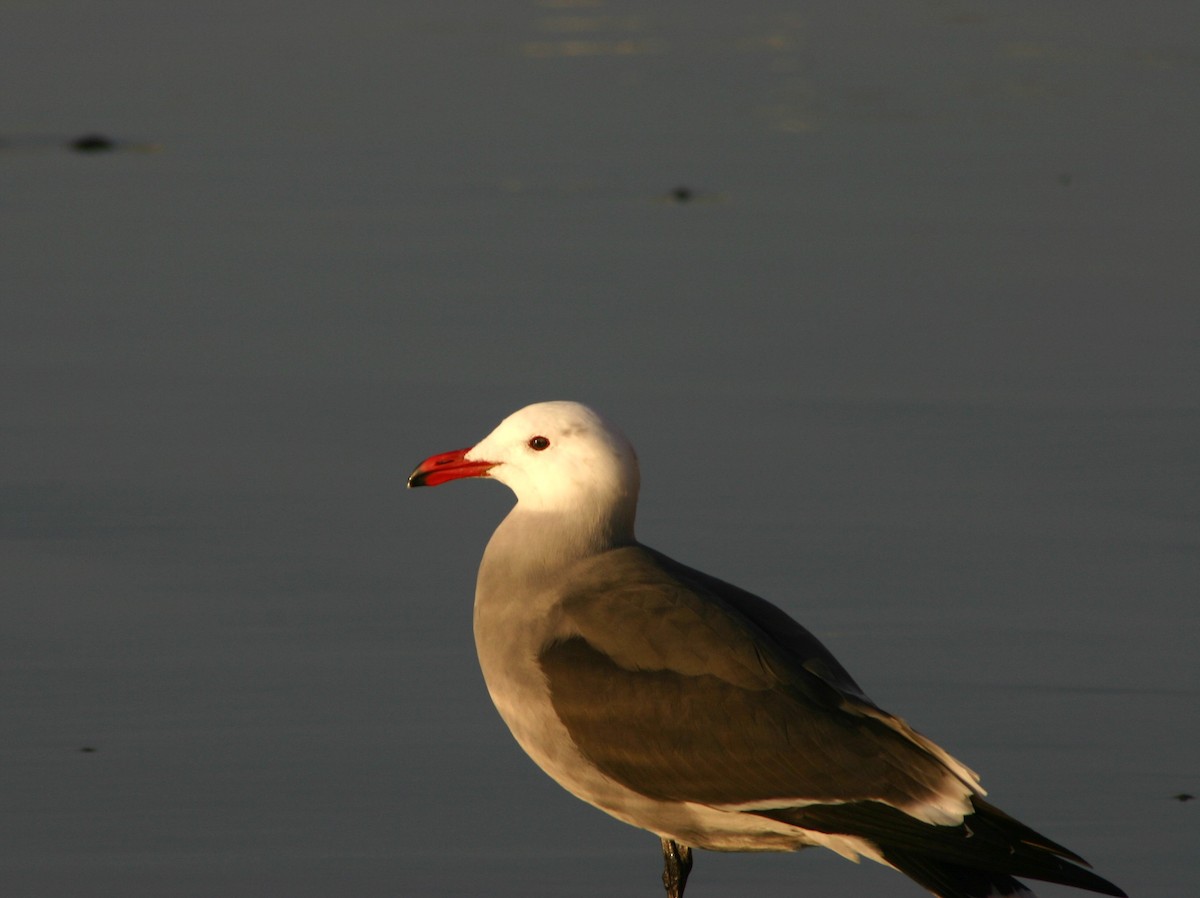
408,401,1126,898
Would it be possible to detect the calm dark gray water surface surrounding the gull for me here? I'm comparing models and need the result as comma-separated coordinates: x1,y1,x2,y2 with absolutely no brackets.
0,0,1200,898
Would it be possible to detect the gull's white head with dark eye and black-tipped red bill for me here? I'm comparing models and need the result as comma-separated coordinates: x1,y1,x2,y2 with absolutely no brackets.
408,402,640,539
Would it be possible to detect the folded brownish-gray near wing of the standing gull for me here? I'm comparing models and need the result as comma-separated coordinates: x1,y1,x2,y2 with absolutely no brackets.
539,546,982,822
